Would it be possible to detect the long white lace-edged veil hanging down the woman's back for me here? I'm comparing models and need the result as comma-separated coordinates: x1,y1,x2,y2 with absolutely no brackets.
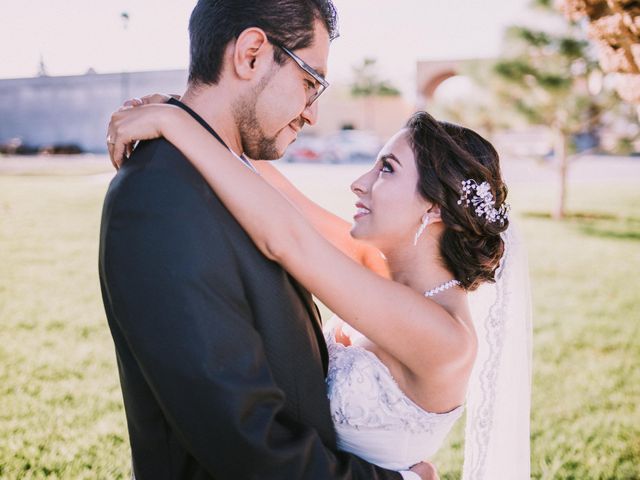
462,222,532,480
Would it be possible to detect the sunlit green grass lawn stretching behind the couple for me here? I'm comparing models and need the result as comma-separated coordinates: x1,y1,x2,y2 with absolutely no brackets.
0,160,640,479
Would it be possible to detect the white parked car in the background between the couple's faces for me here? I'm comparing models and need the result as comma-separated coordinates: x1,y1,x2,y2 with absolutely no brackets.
322,130,382,163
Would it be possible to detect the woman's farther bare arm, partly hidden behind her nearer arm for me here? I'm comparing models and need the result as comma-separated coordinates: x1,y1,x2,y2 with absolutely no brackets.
253,161,389,278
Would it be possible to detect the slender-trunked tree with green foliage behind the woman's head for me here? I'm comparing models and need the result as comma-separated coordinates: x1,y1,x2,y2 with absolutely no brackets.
492,0,614,219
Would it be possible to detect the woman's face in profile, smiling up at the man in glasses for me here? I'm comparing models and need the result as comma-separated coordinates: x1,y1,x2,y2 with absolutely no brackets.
351,130,430,252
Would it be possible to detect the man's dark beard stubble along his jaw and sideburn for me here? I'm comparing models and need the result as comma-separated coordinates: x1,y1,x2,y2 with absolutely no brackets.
233,74,284,160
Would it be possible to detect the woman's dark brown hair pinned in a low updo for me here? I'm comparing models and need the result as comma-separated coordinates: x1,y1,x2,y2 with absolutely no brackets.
406,112,509,291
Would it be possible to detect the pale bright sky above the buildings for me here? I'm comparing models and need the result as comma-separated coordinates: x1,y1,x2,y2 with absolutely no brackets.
0,0,528,97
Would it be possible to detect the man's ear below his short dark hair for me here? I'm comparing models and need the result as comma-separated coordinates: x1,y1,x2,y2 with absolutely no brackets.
232,27,273,80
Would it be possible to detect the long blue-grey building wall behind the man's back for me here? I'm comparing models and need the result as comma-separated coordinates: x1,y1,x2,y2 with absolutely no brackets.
0,70,187,152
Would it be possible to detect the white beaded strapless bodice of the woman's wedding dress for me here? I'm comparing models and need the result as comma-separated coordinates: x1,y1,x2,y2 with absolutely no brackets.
325,324,464,470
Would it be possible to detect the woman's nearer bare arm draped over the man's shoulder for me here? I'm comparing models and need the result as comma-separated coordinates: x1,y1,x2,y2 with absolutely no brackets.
109,105,473,373
